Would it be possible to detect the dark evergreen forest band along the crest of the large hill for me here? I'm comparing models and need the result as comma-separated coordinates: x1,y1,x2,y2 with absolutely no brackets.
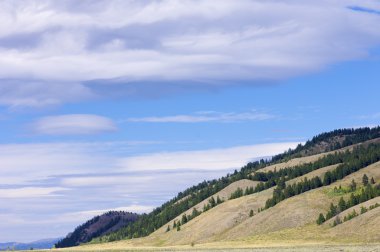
95,127,380,241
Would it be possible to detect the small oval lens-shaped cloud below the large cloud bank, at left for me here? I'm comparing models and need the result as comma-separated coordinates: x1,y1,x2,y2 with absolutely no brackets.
32,114,117,135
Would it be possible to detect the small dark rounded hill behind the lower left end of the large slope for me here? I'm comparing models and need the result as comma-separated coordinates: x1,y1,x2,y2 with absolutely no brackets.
55,211,139,248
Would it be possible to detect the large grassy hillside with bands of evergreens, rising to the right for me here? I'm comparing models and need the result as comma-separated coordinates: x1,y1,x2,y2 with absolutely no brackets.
52,128,380,249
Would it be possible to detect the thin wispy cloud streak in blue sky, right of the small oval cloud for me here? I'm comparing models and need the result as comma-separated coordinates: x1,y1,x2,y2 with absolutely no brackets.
126,111,275,123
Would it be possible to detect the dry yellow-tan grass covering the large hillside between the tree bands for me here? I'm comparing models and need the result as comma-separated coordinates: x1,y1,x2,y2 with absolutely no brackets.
49,139,380,250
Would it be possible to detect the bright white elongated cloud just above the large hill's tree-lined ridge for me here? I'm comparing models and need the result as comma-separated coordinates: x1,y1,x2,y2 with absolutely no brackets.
119,142,299,171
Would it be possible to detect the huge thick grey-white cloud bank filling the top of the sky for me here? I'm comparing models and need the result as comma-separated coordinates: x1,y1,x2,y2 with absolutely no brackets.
0,0,380,106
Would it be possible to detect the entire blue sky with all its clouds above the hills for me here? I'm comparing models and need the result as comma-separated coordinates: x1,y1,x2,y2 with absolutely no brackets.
0,0,380,242
